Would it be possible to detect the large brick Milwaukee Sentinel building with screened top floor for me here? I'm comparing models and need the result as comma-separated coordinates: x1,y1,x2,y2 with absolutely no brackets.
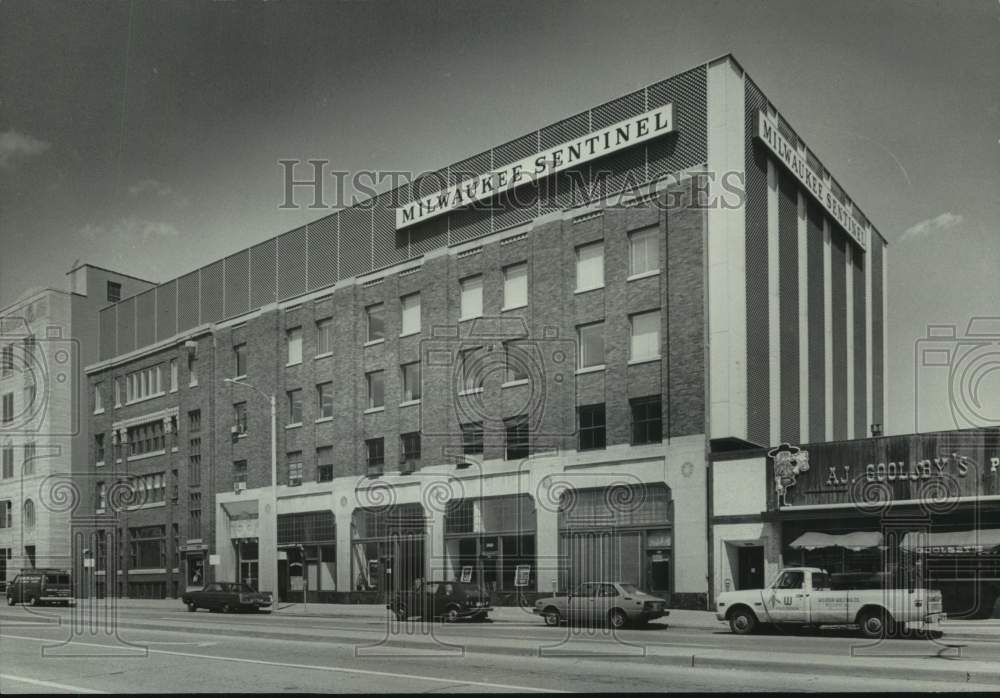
82,56,885,606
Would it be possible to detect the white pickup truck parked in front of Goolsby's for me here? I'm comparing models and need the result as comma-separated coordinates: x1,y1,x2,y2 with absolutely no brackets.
715,567,944,638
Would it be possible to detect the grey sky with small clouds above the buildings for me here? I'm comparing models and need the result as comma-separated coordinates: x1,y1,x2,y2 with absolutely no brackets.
0,0,1000,433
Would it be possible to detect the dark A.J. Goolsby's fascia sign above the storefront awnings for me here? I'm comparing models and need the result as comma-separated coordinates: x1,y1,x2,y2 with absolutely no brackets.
770,429,1000,508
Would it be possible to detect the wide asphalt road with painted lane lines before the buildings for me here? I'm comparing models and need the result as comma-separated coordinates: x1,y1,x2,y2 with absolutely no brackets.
0,607,998,694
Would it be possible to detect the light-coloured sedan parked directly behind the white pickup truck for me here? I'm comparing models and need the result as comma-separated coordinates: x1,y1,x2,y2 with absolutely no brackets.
532,582,670,628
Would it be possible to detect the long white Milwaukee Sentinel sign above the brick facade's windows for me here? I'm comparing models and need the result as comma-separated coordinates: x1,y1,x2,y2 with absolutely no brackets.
396,104,674,228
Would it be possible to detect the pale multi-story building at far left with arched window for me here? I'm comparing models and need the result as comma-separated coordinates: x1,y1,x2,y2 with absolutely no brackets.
0,264,153,585
